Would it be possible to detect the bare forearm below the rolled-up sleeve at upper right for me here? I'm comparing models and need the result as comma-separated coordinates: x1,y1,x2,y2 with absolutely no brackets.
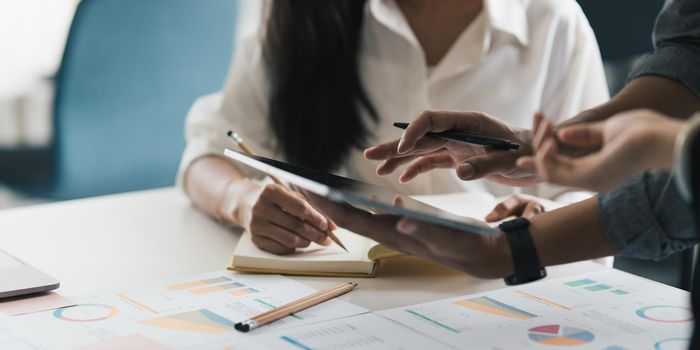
562,75,700,125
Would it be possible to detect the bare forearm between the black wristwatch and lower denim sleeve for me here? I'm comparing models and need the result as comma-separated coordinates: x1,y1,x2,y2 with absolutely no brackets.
530,196,616,266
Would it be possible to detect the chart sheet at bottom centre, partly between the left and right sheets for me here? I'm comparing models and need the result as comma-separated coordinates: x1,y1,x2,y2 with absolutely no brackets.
188,314,451,350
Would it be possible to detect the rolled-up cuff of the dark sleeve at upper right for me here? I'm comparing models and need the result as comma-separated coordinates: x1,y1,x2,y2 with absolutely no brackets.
628,44,700,96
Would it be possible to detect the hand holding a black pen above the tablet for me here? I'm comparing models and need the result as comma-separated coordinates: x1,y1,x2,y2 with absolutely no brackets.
365,111,538,186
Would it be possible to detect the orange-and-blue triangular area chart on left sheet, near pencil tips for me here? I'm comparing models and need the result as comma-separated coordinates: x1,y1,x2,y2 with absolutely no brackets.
138,309,236,333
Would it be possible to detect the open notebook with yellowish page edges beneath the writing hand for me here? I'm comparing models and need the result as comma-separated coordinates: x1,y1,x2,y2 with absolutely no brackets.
228,192,497,277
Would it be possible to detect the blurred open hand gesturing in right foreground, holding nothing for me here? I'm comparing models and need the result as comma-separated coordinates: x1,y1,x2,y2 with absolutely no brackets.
518,110,683,191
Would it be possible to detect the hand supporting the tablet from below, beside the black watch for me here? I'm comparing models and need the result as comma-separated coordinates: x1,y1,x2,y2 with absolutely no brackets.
306,193,513,278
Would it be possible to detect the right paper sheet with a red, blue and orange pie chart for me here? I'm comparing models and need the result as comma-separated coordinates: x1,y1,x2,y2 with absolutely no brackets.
378,270,693,350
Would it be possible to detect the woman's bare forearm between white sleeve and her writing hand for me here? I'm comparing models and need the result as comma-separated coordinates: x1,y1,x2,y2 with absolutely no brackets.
184,156,247,219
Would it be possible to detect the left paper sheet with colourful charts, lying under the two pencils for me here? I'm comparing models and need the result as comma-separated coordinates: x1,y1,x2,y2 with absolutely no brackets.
0,271,367,350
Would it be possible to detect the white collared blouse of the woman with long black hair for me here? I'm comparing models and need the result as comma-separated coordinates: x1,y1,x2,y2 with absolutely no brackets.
178,0,609,198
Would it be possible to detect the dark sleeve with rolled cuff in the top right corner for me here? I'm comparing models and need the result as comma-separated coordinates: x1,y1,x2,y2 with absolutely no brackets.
629,0,700,96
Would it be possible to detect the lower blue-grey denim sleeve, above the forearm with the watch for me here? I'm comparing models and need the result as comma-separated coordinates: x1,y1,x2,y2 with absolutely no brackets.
598,172,698,260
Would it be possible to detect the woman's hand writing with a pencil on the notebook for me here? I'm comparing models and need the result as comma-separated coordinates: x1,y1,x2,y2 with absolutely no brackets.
223,180,334,254
